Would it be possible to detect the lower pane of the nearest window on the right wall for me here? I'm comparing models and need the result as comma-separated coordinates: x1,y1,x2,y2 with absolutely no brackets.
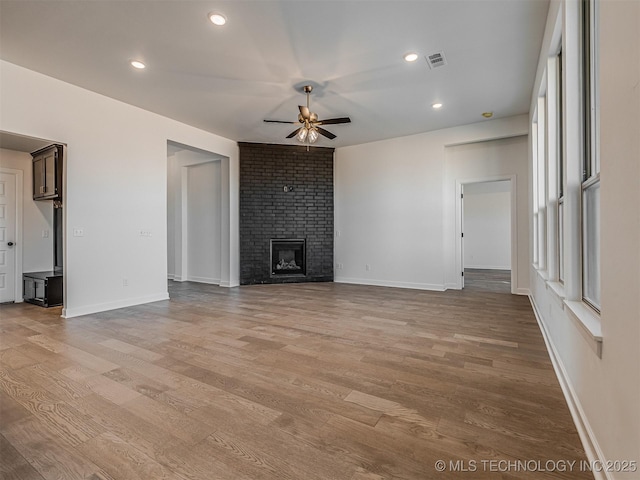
582,181,600,310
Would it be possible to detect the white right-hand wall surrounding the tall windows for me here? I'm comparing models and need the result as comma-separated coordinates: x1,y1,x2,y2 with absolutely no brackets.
531,1,640,480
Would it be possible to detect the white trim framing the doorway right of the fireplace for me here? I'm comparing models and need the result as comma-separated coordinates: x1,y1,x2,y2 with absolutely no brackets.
454,174,521,294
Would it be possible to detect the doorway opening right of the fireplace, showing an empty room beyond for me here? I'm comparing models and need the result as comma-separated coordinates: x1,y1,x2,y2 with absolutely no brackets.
458,178,517,293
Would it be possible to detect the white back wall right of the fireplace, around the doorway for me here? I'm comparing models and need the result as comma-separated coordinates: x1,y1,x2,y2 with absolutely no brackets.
334,115,529,291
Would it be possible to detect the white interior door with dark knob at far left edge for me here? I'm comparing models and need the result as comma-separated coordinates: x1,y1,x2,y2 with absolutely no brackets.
0,173,16,302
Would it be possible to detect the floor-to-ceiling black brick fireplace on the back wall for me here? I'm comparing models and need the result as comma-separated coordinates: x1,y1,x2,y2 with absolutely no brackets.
239,143,334,285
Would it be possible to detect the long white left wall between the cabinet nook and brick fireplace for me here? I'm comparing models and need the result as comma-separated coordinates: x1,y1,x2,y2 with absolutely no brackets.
0,61,239,317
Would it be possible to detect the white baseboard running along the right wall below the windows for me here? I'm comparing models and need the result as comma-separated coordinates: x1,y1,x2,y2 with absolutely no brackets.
529,295,614,480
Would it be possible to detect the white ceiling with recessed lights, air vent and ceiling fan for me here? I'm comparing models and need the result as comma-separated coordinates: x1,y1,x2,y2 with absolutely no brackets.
0,0,549,147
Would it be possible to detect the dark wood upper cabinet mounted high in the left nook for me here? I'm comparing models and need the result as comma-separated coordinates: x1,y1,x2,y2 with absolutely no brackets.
31,145,63,200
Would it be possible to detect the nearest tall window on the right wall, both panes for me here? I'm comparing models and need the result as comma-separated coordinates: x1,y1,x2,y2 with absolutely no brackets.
581,0,600,311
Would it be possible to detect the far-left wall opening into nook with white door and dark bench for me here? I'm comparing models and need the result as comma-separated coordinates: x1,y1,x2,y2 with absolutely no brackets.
0,131,67,308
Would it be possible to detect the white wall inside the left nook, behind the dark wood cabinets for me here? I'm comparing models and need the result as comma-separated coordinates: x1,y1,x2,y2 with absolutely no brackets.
0,149,54,272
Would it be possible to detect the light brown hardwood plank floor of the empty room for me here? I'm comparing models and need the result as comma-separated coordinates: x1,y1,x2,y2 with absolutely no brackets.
0,281,593,480
